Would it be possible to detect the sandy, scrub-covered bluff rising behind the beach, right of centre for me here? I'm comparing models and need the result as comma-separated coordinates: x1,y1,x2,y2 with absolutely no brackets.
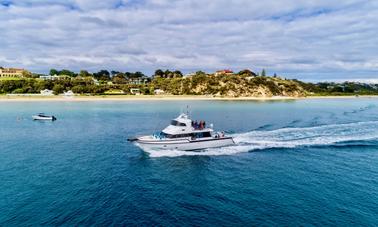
151,72,305,97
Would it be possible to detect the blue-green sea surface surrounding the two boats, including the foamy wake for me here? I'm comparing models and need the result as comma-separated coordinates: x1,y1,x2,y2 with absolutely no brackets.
0,98,378,226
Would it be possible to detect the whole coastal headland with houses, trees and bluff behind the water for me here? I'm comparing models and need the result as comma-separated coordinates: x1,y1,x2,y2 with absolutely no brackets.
0,67,378,100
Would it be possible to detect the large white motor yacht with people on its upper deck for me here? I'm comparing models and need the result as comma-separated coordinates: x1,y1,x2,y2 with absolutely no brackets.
129,114,235,151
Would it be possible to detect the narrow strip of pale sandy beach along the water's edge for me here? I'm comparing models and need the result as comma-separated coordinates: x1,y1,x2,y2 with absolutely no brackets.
0,95,378,102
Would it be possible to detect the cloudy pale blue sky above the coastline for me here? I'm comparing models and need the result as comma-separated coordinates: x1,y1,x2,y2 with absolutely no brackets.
0,0,378,81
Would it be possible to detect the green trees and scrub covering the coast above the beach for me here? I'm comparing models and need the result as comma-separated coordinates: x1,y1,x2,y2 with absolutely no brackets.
0,69,378,97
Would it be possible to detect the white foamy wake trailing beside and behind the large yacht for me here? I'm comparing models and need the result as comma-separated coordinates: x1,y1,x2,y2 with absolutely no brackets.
142,121,378,157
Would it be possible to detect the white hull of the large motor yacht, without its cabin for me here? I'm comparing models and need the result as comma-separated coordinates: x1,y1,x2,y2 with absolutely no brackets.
135,137,235,151
